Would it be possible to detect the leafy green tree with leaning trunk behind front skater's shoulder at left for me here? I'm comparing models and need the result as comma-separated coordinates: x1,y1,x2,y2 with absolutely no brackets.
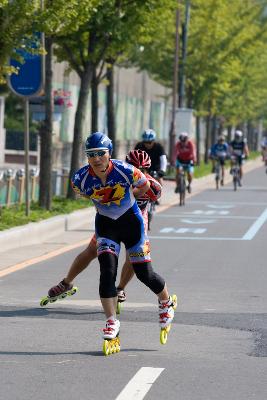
54,0,176,197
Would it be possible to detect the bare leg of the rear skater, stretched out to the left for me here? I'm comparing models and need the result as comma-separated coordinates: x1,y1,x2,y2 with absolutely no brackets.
64,239,97,284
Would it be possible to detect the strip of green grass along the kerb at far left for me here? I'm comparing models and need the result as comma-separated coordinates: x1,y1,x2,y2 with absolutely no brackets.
0,197,92,231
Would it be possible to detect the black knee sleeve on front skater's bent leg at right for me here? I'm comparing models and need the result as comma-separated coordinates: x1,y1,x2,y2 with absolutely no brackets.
133,262,165,294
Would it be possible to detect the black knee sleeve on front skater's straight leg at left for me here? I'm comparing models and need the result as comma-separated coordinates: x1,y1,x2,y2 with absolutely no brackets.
98,253,118,298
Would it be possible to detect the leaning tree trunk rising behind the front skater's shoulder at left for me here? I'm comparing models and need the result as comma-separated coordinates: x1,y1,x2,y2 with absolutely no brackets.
67,62,93,199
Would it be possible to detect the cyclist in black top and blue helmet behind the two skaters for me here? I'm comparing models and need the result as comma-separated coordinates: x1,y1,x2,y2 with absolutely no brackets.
135,129,167,185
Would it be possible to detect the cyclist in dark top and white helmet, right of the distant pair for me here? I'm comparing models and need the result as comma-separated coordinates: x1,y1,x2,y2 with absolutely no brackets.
229,130,249,186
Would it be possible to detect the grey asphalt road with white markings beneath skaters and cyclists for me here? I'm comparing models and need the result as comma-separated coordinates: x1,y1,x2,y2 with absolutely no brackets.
0,163,267,400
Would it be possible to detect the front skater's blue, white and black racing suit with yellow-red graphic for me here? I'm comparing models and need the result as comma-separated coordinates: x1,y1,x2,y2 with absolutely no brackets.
72,160,151,263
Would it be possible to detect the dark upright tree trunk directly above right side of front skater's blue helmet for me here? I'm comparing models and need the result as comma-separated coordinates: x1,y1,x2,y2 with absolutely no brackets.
107,62,117,158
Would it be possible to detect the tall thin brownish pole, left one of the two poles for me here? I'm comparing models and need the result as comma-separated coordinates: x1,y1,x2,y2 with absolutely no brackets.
169,0,180,165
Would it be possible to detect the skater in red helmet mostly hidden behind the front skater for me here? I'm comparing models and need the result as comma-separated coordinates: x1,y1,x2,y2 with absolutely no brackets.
48,150,161,302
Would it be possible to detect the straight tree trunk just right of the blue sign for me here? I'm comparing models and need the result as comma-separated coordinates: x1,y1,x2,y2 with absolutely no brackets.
39,37,53,210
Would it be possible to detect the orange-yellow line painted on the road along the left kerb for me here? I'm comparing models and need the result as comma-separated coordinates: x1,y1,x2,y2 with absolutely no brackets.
0,239,89,278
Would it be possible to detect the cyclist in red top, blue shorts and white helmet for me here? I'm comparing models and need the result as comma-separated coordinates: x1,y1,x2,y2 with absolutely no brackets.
175,132,196,193
